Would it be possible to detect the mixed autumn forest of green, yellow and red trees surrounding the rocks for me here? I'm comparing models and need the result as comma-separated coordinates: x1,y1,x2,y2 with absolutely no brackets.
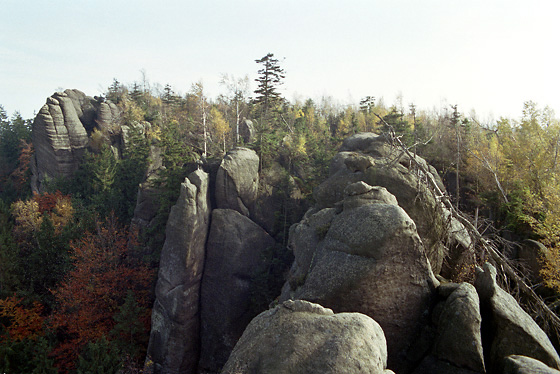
0,54,560,373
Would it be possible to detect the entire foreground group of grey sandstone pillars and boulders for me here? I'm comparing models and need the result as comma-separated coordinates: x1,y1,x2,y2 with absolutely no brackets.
140,130,560,374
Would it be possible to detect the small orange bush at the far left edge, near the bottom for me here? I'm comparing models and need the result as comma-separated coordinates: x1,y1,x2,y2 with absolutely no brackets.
0,295,44,341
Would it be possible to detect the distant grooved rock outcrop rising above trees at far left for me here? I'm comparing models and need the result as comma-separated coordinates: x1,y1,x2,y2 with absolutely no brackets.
32,90,120,191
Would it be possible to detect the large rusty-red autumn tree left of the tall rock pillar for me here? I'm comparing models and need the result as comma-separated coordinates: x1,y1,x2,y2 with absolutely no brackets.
52,218,153,368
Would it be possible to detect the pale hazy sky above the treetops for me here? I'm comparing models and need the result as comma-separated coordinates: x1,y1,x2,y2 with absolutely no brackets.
0,0,560,118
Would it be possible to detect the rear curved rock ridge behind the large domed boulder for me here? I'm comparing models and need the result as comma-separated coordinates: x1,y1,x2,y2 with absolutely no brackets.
314,133,470,274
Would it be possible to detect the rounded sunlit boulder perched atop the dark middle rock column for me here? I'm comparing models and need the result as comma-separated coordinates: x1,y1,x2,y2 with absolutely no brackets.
216,147,259,217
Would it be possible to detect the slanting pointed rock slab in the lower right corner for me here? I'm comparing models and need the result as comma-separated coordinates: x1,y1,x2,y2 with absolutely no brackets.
475,263,560,372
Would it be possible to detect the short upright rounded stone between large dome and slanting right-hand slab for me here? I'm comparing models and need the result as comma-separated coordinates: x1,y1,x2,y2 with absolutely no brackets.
434,283,485,373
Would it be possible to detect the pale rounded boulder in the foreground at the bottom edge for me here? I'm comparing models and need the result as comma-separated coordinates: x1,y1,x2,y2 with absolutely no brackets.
222,300,390,374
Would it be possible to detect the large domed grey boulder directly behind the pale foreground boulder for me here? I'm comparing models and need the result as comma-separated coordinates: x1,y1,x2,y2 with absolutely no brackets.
281,182,437,372
